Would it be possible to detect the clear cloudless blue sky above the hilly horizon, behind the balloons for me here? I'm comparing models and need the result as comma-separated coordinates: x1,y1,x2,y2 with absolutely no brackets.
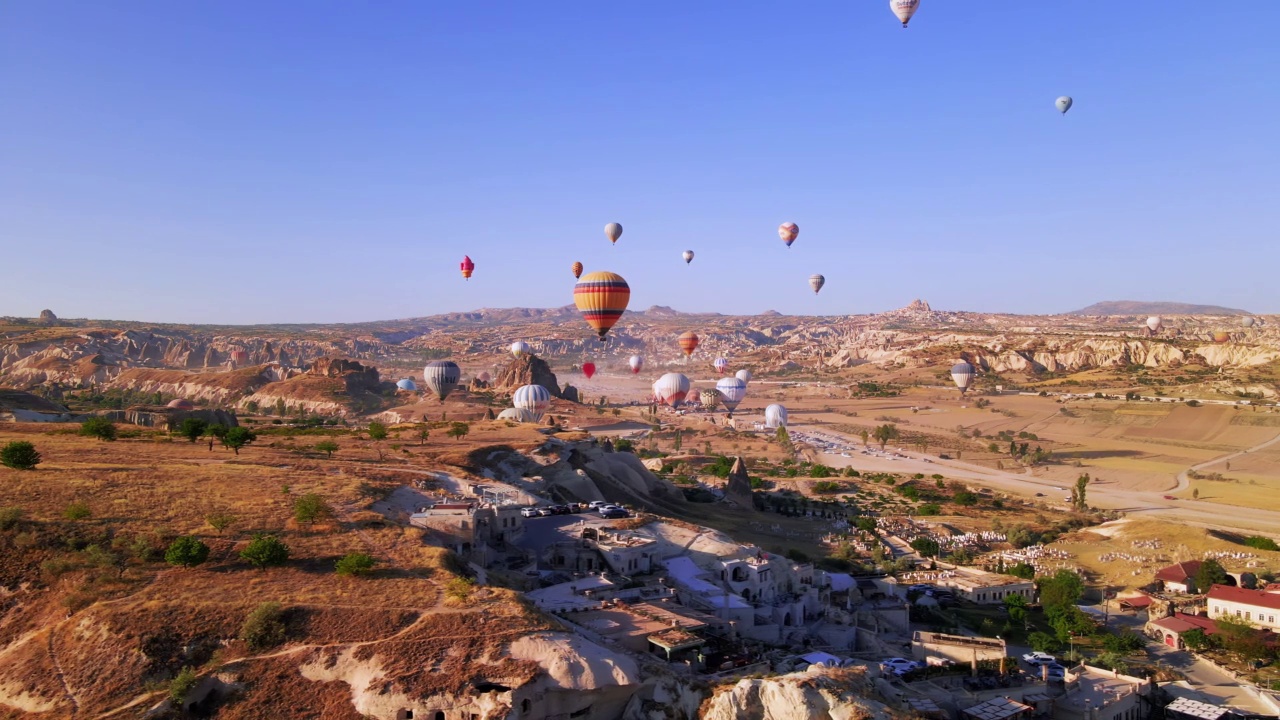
0,0,1280,323
